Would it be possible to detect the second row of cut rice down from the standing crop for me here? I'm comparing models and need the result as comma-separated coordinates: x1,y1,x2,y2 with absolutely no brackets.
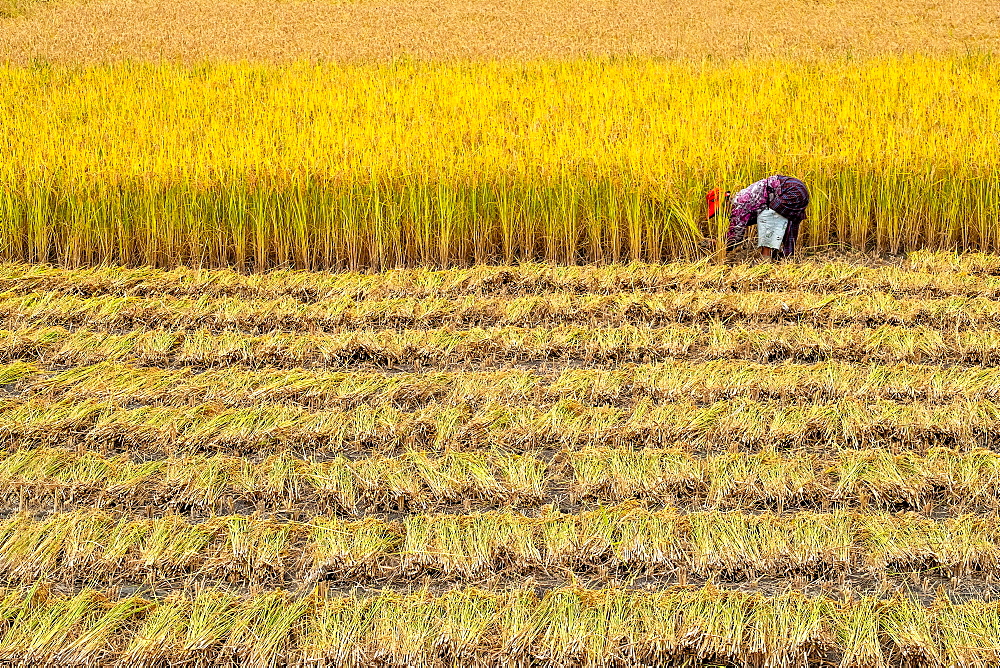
0,290,1000,333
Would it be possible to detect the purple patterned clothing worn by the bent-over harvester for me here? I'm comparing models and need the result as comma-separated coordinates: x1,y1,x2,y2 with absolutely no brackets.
726,174,809,256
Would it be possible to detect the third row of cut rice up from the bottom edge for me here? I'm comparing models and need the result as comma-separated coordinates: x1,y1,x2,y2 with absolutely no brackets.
0,446,1000,517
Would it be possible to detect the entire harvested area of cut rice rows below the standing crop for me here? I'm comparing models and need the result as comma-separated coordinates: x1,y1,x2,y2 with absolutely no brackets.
0,251,1000,668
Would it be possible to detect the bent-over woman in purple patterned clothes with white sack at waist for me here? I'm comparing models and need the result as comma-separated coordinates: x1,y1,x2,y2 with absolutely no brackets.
712,175,809,259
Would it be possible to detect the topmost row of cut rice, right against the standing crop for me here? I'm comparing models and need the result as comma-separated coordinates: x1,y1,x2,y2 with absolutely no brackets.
0,251,1000,302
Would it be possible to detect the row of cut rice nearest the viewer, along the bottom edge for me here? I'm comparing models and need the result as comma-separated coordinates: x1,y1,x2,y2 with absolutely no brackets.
0,586,1000,668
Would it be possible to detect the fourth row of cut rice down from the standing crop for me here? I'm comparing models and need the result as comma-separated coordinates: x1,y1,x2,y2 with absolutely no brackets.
15,360,1000,410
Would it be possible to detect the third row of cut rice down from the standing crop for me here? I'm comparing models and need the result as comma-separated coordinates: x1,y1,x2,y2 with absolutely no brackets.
0,321,1000,369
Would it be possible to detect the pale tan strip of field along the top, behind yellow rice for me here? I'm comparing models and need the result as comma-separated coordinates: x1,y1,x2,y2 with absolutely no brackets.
0,0,1000,63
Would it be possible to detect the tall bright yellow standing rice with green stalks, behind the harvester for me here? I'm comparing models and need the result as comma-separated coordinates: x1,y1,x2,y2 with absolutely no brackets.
0,56,1000,269
